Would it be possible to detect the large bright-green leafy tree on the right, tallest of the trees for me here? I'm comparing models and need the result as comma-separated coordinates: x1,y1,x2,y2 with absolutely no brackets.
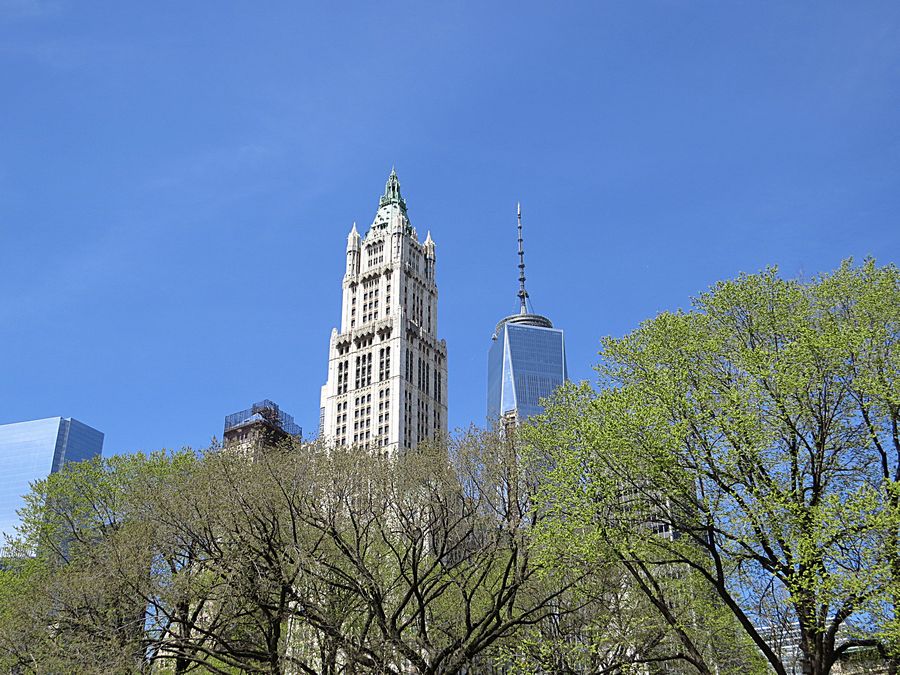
532,261,900,675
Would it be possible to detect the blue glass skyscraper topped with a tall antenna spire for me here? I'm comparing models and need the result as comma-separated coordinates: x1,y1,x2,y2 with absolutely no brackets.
487,207,568,423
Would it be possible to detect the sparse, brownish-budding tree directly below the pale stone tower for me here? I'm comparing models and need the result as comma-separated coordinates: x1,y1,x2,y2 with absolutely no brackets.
236,433,592,673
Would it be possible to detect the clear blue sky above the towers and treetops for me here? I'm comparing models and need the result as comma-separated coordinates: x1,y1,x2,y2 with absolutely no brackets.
0,0,900,454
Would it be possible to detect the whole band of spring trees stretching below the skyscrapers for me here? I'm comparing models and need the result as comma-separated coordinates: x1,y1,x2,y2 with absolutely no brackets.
0,261,900,675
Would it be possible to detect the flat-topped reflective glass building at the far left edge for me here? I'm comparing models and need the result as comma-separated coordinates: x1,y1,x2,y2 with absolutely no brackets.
0,417,103,548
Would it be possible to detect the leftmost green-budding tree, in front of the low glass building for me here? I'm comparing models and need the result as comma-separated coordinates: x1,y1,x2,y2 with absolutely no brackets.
0,451,206,673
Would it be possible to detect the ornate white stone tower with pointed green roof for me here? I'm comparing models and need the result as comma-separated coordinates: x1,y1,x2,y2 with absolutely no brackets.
320,170,447,454
